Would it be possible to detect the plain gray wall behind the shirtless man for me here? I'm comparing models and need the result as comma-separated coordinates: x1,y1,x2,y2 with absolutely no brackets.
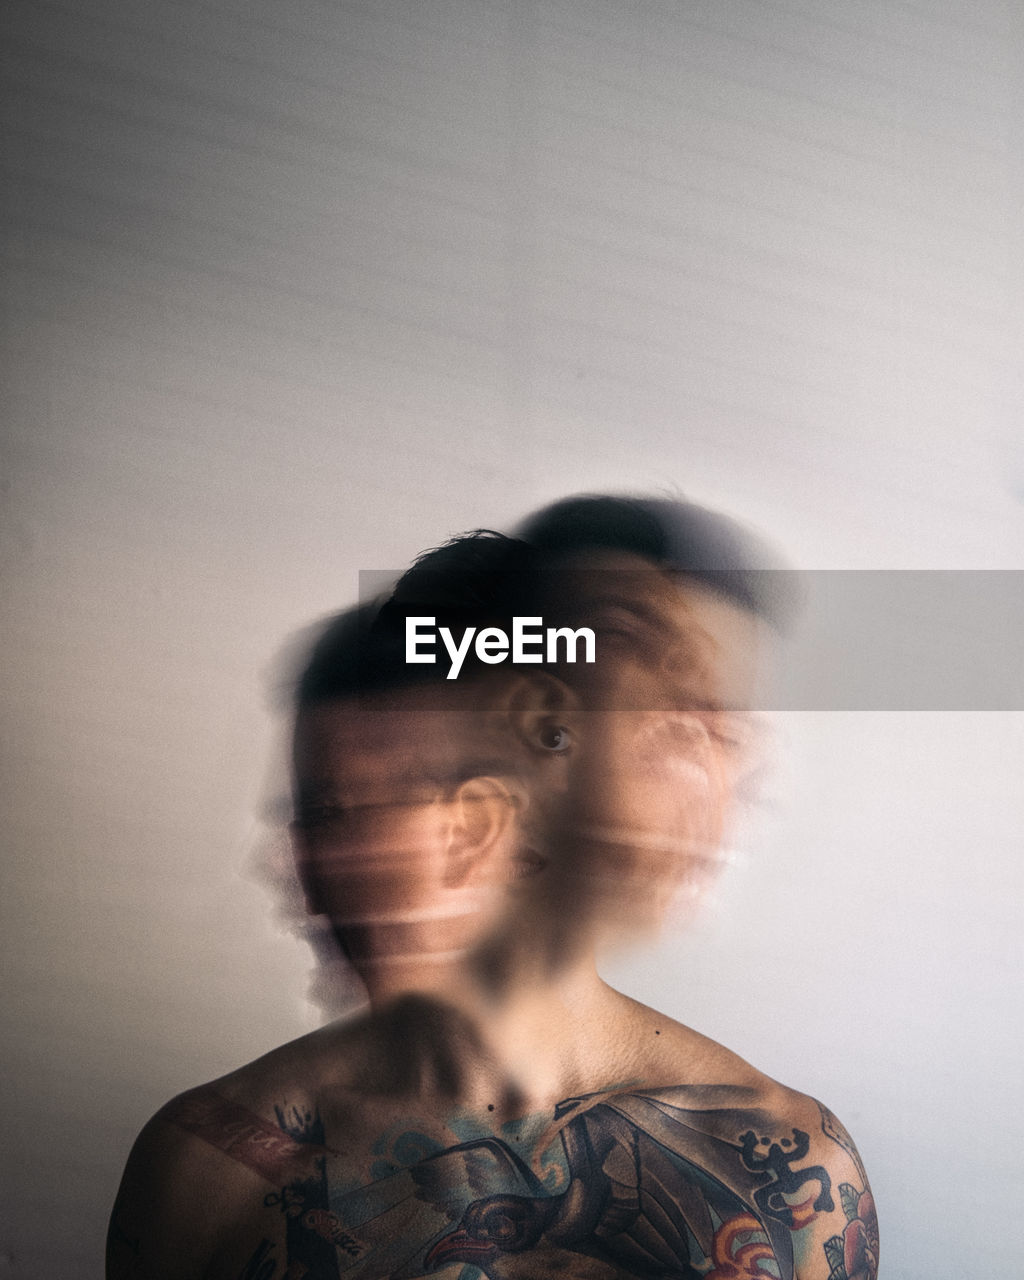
0,0,1024,1280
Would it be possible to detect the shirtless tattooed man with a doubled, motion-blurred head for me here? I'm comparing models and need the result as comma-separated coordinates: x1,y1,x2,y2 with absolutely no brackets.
109,494,878,1280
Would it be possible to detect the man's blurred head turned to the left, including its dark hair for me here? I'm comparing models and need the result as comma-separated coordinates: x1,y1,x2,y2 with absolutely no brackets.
293,534,576,989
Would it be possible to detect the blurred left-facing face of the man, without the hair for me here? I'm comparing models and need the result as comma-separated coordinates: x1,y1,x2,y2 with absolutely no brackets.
294,694,511,977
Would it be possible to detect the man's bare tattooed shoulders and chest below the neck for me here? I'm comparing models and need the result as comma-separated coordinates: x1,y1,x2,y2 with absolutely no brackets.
110,979,873,1280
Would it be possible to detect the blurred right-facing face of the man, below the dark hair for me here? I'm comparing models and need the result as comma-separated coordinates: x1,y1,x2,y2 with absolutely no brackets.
540,554,759,933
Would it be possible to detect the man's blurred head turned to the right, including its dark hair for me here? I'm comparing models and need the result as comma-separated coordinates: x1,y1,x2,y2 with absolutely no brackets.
506,495,792,934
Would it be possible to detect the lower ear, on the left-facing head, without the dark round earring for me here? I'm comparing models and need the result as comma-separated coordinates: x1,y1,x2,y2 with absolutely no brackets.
445,777,522,888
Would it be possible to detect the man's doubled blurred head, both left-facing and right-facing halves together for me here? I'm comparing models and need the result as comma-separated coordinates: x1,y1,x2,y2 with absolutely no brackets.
294,497,786,983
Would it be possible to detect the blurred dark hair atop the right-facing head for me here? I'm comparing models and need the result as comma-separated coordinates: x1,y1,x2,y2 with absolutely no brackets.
517,494,797,627
